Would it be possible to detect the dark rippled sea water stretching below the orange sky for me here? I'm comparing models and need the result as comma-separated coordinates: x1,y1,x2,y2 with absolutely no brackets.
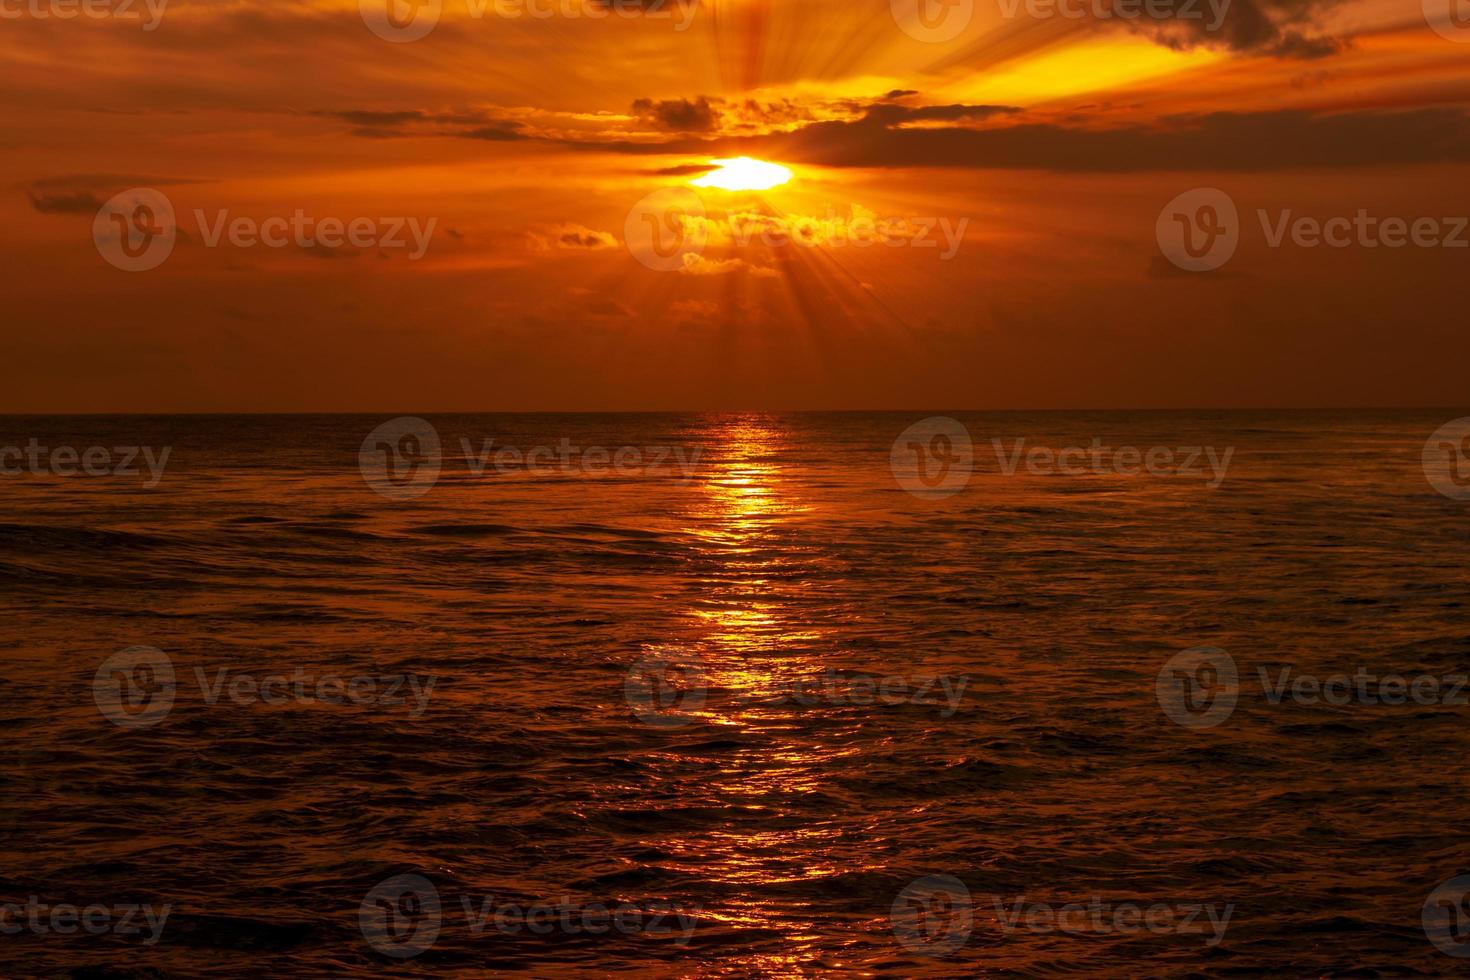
0,411,1470,977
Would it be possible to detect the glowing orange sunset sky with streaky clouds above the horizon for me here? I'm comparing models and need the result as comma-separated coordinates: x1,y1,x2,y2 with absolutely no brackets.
0,0,1470,411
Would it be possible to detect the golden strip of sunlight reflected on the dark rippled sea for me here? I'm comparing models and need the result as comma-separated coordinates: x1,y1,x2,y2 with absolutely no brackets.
666,416,876,977
